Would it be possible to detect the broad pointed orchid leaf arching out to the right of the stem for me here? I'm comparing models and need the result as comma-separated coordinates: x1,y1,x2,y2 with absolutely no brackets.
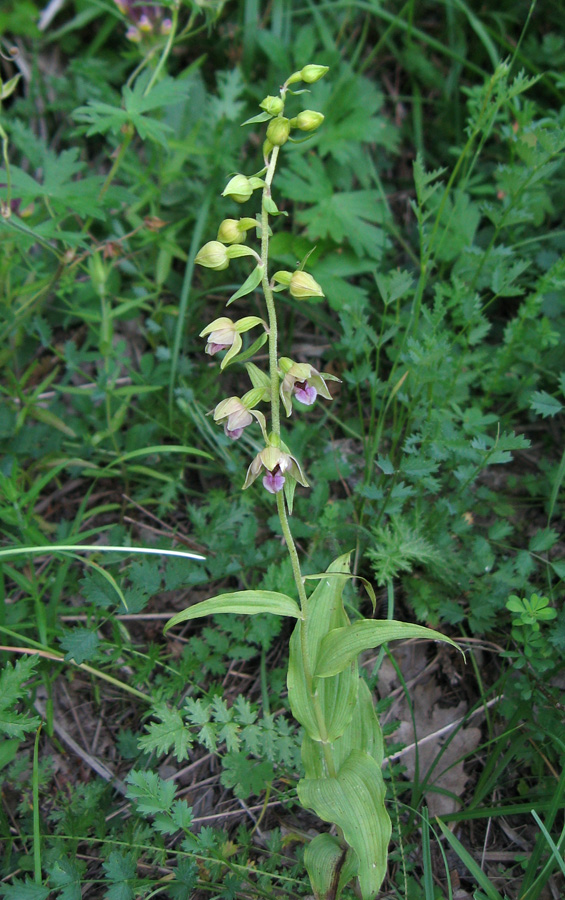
315,619,459,678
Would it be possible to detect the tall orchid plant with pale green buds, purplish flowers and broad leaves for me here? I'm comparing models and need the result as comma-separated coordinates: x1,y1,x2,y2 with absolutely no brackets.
166,65,453,900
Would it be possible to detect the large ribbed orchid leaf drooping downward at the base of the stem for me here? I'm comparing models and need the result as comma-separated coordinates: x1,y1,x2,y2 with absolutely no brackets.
298,750,391,900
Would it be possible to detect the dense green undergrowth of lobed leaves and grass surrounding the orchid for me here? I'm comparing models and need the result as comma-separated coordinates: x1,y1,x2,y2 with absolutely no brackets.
0,0,565,900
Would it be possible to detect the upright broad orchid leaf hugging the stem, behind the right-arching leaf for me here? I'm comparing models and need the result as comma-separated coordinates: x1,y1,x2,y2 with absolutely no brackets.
287,553,359,741
